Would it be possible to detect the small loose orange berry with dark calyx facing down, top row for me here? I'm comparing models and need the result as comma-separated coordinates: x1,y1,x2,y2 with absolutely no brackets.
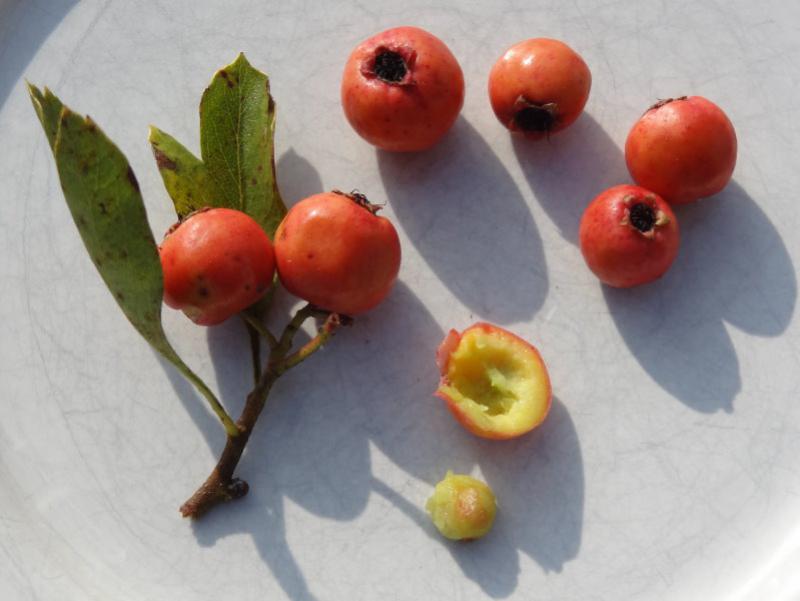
489,38,592,139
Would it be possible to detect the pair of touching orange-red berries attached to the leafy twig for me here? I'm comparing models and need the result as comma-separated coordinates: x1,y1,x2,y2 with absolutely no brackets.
159,191,400,326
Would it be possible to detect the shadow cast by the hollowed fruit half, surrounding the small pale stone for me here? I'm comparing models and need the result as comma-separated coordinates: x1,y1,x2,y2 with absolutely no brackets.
373,399,584,599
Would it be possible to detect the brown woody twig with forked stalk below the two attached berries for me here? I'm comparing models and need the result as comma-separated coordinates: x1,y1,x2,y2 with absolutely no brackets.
180,305,350,518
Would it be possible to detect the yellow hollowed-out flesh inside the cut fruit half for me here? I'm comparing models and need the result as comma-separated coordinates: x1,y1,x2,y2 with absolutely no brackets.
440,330,549,432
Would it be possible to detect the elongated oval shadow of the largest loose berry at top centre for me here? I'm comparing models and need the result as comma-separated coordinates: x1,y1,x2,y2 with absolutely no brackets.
378,118,548,323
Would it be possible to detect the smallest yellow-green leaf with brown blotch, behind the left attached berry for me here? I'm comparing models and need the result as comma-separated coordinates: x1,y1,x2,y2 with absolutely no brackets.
148,125,212,219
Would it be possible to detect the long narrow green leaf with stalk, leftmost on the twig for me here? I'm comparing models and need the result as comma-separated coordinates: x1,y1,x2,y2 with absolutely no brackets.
28,85,238,436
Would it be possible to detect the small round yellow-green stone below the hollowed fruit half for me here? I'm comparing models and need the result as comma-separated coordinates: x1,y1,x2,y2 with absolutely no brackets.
425,472,497,540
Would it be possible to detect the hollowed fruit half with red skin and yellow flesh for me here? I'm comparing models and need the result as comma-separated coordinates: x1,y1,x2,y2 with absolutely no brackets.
436,323,552,440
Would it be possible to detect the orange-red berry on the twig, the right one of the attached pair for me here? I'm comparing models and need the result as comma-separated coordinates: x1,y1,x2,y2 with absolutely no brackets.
275,192,400,315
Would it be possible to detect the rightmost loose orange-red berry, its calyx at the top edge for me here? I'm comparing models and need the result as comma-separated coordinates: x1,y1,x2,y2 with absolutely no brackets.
625,96,736,204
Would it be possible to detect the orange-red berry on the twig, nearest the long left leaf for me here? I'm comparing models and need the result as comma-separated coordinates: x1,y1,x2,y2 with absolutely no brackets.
158,209,275,326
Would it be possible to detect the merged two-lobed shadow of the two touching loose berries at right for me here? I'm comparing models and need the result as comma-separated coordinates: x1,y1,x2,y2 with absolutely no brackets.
603,182,797,413
